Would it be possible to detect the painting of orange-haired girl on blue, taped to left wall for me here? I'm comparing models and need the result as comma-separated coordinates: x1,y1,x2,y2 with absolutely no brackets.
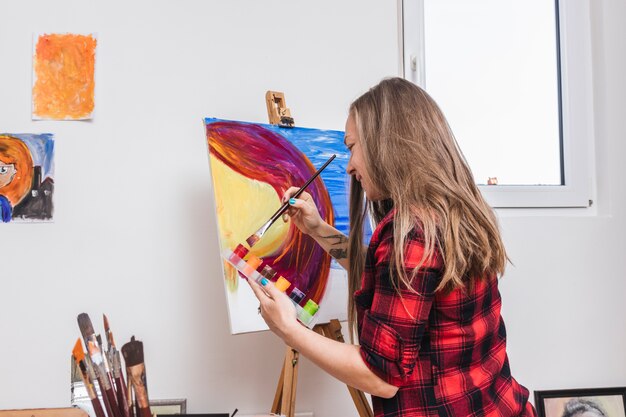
0,133,54,223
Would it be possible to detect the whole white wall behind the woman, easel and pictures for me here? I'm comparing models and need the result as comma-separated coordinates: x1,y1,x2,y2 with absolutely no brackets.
0,0,626,417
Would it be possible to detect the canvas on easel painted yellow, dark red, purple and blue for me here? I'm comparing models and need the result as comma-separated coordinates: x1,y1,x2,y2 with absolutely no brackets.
205,118,349,334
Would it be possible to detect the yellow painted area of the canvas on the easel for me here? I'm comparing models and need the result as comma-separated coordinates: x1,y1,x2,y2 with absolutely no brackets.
210,155,289,290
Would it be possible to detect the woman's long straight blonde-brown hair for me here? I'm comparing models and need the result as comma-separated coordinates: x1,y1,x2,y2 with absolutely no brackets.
348,78,508,335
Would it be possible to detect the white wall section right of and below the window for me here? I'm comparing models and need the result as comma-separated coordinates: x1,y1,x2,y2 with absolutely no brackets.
501,0,626,390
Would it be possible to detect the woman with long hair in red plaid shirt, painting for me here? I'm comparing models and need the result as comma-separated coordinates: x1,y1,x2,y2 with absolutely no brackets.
250,78,535,417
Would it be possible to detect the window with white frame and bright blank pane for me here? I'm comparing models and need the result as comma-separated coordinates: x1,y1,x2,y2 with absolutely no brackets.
402,0,593,207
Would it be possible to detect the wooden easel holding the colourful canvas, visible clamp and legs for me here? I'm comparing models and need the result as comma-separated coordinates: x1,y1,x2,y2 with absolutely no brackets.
265,91,374,417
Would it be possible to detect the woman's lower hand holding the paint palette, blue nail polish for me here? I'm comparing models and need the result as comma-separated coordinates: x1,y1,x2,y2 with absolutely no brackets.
247,278,300,340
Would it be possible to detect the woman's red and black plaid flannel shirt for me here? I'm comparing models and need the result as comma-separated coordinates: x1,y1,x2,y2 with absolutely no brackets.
354,211,536,417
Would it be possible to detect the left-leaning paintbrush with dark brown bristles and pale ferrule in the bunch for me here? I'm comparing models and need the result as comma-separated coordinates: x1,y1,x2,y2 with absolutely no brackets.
78,313,123,417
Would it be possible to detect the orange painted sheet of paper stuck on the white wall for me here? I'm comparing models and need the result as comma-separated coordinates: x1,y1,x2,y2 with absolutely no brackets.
33,34,96,120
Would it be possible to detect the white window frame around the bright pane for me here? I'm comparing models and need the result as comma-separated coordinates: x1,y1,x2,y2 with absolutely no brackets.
398,0,594,208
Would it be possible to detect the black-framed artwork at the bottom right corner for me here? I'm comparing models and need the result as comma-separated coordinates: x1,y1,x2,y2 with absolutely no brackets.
535,387,626,417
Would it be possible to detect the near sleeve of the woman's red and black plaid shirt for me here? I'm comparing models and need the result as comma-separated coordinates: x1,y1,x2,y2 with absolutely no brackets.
359,228,441,387
